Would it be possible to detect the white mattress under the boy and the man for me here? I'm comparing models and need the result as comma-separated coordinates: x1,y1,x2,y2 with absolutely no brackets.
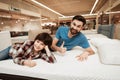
0,48,120,80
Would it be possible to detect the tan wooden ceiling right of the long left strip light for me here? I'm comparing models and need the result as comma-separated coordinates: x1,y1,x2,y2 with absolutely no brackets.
25,0,120,16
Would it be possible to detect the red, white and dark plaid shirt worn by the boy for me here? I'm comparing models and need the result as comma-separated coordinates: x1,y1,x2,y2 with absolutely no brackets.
9,40,56,65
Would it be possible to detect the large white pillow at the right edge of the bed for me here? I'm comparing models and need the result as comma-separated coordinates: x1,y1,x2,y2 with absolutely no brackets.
98,40,120,65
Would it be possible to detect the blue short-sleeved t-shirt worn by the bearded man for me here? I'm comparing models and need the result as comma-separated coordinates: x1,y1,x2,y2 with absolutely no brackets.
56,26,90,50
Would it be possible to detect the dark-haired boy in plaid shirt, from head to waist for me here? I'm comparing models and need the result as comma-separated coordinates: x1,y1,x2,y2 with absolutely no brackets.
0,33,56,67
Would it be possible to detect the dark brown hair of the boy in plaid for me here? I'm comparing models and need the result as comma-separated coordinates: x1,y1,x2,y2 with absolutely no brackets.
34,32,53,48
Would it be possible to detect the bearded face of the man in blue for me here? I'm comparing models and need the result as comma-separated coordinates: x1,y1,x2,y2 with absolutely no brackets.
70,20,83,35
